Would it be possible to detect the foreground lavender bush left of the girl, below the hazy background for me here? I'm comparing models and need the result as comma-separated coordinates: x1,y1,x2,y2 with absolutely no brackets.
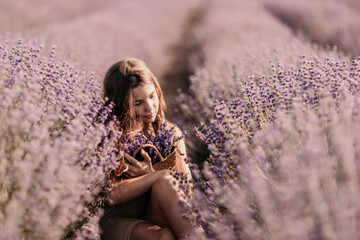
0,41,116,239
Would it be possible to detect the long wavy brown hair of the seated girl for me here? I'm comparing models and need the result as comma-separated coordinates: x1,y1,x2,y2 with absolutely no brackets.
103,58,166,134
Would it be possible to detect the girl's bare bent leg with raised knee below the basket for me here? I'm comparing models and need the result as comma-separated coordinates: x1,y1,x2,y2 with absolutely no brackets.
149,172,195,239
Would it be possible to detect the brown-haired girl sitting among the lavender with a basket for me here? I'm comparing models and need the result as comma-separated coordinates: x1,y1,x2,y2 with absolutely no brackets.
100,58,194,240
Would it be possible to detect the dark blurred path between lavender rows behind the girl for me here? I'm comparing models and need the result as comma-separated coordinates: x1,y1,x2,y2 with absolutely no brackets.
160,6,209,167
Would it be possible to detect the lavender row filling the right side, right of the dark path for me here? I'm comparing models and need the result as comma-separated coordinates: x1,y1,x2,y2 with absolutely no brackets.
179,1,360,239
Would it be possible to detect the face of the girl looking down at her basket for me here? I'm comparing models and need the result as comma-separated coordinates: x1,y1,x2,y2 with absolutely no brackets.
131,84,159,124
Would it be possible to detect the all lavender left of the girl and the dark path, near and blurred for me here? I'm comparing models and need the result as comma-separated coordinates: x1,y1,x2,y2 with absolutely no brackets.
0,0,204,240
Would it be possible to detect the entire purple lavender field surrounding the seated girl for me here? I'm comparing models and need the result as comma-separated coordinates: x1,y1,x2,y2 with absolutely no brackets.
0,0,360,240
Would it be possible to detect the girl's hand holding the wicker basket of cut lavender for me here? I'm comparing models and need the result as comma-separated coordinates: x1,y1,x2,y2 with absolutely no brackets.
125,149,155,177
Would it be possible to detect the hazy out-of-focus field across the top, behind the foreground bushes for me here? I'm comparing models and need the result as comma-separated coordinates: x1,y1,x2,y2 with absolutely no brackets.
0,0,360,119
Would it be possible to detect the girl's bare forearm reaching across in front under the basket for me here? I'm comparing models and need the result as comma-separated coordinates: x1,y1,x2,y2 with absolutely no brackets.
108,171,164,205
